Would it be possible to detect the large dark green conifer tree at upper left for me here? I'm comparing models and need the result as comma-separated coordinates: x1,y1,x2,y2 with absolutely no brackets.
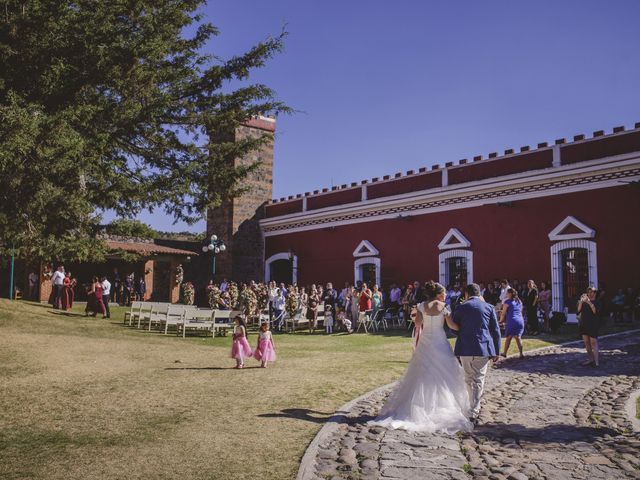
0,0,289,260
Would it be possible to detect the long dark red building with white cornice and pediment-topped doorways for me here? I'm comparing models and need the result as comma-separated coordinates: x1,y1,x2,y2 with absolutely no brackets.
260,123,640,320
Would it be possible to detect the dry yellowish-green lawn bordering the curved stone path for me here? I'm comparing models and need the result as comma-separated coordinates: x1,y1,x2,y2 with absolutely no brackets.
0,300,632,479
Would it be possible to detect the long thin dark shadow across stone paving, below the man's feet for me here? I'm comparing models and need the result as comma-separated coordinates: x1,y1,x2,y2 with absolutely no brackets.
470,423,620,446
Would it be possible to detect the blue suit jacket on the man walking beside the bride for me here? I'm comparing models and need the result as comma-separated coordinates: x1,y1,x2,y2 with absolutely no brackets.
453,297,500,357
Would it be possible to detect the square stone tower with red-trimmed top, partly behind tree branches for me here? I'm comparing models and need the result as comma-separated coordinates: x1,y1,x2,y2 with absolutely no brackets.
205,116,276,282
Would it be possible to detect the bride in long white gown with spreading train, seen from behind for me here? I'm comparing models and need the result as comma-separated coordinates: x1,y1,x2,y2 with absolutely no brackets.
369,282,473,434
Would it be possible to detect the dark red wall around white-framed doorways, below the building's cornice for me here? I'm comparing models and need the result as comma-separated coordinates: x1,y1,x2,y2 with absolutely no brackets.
266,185,640,289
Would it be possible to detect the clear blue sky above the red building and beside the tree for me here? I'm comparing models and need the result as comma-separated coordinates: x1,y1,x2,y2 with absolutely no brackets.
121,0,640,231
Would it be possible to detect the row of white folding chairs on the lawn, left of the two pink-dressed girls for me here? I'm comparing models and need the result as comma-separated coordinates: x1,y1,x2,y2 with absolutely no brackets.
124,301,239,337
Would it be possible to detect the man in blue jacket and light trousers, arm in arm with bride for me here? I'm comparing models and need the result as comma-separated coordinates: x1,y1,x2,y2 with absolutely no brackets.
453,283,500,424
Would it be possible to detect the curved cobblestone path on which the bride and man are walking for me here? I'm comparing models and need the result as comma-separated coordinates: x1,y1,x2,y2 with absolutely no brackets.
298,332,640,480
